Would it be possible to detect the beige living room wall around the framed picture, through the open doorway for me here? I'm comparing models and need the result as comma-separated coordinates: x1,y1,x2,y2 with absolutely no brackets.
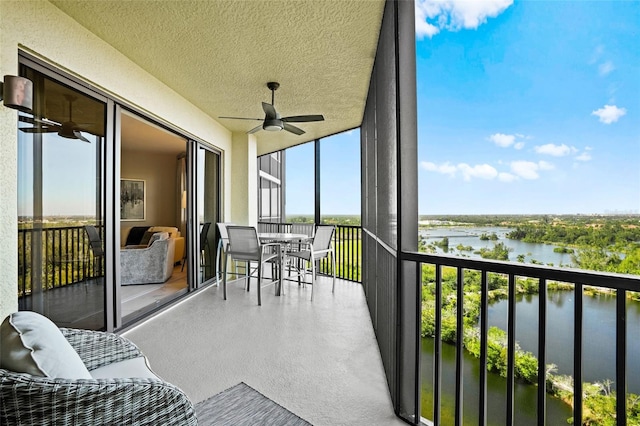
120,150,179,238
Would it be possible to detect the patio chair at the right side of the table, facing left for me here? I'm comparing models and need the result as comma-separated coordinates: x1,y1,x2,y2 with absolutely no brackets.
287,225,336,301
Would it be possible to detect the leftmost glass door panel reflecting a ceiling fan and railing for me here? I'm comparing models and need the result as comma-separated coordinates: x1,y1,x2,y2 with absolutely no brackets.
17,65,106,330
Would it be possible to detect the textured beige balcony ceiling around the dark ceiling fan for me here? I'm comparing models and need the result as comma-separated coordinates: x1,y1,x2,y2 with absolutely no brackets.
50,0,384,153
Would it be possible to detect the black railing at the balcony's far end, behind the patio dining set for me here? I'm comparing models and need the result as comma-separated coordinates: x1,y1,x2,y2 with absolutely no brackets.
258,222,362,282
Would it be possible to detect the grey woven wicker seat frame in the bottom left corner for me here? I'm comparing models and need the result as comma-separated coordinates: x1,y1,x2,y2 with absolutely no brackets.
0,312,198,426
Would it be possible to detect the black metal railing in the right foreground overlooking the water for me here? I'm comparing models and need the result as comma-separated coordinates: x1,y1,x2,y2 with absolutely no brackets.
401,252,640,426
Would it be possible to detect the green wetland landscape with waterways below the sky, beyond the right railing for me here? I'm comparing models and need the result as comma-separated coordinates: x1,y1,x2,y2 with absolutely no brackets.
419,216,640,425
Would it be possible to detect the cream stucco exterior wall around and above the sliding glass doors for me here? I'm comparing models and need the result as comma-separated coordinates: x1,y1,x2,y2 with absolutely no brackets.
0,0,249,320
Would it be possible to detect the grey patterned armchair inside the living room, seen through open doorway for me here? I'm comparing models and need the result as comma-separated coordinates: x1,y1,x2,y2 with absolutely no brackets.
120,232,175,285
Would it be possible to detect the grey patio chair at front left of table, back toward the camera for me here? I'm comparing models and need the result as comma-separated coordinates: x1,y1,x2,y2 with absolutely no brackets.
222,226,282,305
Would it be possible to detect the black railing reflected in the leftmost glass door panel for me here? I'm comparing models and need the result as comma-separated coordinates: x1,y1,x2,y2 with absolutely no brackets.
18,226,104,297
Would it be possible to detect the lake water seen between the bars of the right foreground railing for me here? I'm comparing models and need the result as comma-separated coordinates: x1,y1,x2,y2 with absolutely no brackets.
421,291,640,425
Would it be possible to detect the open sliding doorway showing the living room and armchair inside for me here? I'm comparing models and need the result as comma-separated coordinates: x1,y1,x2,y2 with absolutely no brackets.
118,108,189,324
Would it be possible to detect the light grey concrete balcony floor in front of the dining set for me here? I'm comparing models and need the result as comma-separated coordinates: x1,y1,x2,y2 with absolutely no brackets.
124,277,405,425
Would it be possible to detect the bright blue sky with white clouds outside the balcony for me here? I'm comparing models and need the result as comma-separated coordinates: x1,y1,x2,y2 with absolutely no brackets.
287,0,640,214
